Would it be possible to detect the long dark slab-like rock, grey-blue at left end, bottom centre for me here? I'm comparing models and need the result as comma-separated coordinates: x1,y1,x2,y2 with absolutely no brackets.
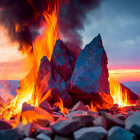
51,116,93,136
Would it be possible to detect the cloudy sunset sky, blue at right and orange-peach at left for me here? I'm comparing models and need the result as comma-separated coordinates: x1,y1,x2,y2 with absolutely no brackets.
0,0,140,82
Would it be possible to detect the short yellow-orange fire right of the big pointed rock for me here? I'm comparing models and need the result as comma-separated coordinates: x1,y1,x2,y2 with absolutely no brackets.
109,77,130,107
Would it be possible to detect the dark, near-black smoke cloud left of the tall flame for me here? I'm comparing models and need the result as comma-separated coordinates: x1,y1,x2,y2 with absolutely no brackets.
0,0,55,50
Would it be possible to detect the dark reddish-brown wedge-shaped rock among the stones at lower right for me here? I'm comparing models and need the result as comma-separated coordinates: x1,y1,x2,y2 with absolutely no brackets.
101,111,125,129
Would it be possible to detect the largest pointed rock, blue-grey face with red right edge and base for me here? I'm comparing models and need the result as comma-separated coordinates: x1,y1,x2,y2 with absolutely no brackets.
70,35,113,104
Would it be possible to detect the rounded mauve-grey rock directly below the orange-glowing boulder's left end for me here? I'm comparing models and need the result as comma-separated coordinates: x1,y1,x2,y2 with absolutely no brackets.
16,123,33,137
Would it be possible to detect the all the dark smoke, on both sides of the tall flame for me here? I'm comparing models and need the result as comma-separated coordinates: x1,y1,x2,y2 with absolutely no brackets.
0,0,102,52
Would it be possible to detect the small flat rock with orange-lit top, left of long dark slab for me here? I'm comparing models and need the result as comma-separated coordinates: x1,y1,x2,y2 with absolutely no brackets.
35,125,53,136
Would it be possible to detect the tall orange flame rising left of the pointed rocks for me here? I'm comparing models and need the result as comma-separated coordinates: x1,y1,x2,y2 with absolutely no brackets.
4,0,61,120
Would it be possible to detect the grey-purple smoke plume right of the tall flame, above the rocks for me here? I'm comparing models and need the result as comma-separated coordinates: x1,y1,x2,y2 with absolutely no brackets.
59,0,103,53
